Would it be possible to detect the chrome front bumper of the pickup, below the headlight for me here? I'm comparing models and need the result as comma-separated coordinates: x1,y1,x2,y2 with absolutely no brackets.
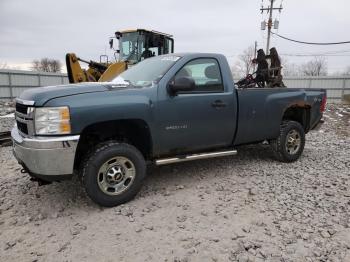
11,127,79,176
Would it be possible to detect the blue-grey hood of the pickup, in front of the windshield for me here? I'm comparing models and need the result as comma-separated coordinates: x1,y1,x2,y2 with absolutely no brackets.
19,82,111,106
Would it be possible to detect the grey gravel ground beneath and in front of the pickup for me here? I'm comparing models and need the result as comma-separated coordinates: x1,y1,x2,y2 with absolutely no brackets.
0,105,350,261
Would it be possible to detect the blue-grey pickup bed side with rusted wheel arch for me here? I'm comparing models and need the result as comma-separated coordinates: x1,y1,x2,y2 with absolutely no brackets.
234,88,325,145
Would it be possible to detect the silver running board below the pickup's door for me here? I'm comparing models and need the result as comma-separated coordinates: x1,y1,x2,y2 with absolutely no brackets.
156,150,237,166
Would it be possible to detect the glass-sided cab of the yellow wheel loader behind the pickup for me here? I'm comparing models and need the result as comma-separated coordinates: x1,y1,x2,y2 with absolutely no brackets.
115,29,174,65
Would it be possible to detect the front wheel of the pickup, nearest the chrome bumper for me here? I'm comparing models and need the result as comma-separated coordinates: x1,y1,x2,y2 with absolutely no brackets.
81,141,146,207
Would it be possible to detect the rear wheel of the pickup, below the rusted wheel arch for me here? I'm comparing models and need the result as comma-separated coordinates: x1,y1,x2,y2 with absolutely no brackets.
271,121,305,163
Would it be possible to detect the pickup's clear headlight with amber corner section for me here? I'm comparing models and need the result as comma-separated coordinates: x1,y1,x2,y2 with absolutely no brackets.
34,106,71,135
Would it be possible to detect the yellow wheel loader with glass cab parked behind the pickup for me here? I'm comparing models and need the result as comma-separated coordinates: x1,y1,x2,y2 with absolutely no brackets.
66,29,174,83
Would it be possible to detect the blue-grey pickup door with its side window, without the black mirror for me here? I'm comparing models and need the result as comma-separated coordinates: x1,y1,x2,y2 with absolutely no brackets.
157,58,235,155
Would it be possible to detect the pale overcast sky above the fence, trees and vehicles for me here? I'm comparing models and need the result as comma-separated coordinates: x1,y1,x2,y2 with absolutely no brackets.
0,0,350,72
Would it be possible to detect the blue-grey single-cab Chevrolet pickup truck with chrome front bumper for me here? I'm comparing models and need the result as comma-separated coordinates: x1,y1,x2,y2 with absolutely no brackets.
12,53,326,207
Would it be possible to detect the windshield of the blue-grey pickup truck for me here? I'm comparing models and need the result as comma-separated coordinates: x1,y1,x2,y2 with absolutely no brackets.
112,56,180,87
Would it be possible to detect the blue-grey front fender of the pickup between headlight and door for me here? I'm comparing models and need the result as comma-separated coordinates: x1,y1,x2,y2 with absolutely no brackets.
45,87,156,134
